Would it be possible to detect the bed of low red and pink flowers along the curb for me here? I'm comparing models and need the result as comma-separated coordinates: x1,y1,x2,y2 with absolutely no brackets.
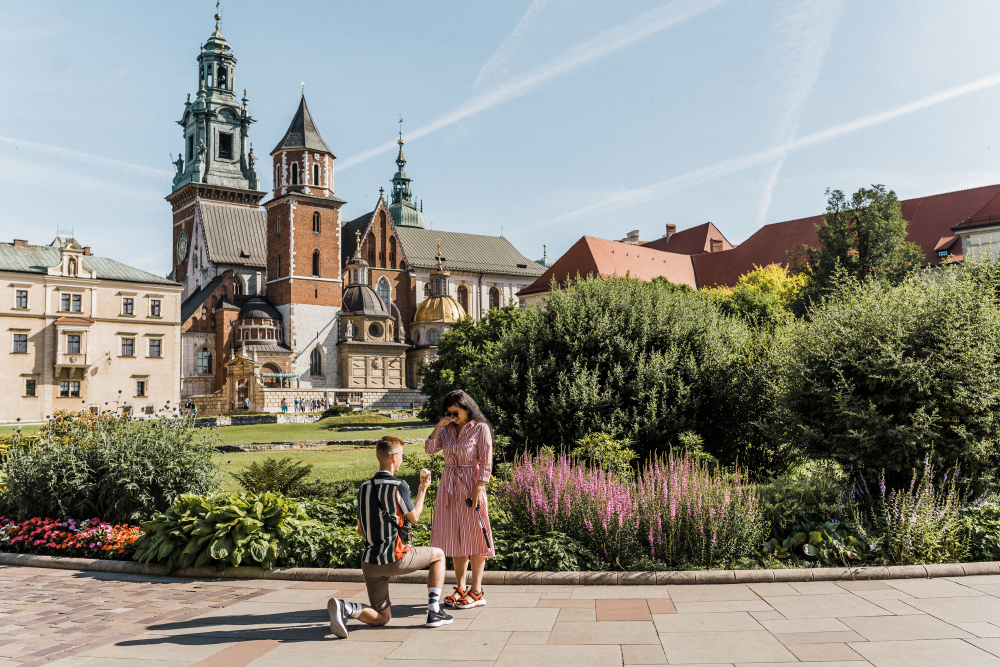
0,517,143,560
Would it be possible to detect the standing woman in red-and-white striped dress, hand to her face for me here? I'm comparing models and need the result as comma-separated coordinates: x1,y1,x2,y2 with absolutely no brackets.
424,389,496,609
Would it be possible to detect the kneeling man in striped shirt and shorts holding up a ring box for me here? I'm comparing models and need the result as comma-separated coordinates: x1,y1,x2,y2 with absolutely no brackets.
326,435,453,639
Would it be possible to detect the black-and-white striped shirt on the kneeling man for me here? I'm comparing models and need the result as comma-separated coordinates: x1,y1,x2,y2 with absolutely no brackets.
358,470,413,565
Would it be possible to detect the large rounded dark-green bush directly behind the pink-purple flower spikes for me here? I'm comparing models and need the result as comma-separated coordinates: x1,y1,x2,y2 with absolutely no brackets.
472,278,783,469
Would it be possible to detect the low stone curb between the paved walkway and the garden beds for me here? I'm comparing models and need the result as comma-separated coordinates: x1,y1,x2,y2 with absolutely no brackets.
0,553,1000,586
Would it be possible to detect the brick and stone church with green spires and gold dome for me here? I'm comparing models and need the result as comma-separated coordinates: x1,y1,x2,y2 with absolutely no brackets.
174,15,546,414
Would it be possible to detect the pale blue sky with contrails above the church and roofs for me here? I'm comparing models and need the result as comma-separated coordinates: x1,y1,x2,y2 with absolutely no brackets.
0,0,1000,274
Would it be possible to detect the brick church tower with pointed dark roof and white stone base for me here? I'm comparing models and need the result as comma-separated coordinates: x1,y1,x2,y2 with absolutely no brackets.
264,95,345,387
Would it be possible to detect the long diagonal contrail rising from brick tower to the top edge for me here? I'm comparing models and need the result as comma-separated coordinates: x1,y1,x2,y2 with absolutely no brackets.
337,0,726,170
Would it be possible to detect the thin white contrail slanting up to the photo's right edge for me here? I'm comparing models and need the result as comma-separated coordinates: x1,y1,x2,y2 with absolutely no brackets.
512,72,1000,235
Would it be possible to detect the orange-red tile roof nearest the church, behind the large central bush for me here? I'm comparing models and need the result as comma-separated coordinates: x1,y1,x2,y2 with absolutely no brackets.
518,236,697,296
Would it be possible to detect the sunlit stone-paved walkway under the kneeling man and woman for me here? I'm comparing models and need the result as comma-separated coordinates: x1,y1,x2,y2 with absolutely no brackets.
0,567,1000,667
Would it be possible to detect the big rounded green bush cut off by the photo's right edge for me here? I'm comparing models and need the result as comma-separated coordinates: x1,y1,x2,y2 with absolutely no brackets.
775,270,1000,488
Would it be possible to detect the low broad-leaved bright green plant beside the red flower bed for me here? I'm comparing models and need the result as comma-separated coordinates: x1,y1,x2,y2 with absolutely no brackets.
135,493,316,572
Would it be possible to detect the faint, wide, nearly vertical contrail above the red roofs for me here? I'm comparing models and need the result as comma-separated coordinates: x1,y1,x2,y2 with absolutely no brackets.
757,0,841,227
